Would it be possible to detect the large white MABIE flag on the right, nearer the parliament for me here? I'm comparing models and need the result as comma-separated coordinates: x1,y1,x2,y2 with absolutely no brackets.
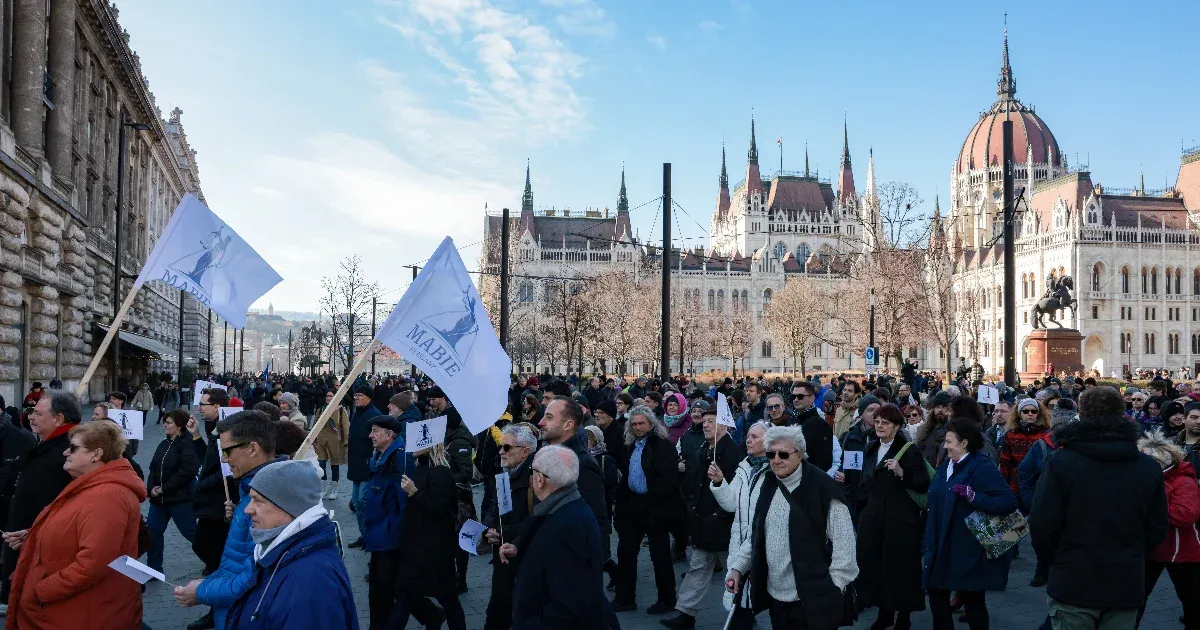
378,236,512,433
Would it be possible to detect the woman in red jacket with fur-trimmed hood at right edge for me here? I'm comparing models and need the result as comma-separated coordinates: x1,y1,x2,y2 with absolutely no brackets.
1138,431,1200,630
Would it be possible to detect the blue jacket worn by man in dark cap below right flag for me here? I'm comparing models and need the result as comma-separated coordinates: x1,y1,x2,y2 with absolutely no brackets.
361,436,415,551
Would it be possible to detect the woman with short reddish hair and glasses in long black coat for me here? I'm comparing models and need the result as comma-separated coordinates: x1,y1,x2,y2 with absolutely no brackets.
857,404,930,630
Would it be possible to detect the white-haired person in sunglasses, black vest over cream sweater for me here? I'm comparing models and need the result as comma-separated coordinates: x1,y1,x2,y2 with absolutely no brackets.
725,426,858,630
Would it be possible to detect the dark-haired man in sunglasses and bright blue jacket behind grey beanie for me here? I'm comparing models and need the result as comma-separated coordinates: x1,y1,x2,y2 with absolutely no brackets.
175,410,287,630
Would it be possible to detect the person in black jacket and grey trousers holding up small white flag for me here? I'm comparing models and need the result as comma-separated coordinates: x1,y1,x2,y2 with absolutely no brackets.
661,406,745,629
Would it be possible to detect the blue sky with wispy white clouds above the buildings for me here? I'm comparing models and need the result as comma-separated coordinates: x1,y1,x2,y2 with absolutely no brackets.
119,0,1200,310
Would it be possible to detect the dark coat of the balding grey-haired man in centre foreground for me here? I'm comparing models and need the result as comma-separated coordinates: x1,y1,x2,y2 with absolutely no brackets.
512,486,611,630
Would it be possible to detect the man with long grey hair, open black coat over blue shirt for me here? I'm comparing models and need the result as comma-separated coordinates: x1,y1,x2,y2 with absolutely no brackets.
613,407,684,614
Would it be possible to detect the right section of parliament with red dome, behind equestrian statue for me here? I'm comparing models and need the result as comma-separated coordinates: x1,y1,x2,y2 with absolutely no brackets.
947,36,1200,377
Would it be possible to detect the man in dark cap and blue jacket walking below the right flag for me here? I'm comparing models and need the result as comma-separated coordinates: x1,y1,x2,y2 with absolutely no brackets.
361,415,415,630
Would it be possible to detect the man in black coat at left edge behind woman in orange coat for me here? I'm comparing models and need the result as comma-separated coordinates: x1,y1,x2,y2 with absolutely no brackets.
0,390,83,601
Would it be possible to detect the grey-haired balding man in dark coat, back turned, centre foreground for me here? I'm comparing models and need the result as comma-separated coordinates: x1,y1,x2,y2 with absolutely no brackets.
499,445,607,630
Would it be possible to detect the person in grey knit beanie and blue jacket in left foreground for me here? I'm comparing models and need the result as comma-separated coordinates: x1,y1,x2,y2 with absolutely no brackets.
224,461,359,630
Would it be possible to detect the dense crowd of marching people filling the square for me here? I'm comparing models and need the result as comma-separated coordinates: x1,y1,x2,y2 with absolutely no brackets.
0,371,1200,630
